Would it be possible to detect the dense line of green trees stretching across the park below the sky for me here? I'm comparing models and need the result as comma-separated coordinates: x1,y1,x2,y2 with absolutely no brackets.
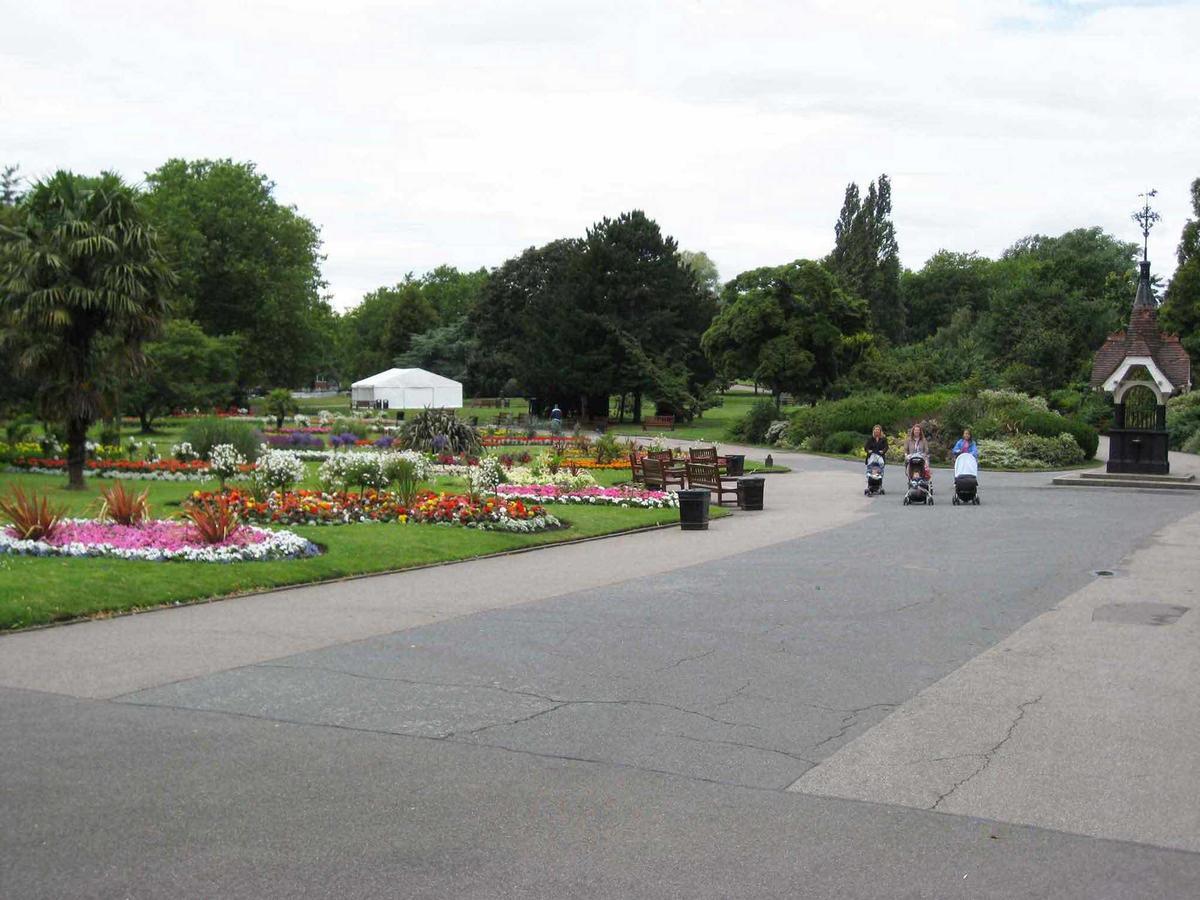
0,160,1200,458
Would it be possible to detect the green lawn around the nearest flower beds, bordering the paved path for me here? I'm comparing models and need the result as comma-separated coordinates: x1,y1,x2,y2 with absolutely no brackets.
0,464,727,629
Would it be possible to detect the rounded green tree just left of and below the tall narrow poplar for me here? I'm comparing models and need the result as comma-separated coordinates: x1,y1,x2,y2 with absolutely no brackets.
702,259,871,404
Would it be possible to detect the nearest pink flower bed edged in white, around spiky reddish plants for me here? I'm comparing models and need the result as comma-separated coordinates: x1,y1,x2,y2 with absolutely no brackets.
0,518,319,563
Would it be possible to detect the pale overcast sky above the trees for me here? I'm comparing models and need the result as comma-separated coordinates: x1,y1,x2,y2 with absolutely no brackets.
0,0,1200,308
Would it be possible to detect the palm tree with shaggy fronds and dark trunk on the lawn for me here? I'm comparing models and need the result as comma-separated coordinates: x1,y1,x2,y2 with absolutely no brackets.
0,172,174,488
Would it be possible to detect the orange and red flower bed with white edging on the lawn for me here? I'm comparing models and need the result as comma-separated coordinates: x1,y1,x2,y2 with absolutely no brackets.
200,491,562,532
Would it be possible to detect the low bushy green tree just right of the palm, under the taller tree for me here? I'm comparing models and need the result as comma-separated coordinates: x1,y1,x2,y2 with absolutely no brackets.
121,319,239,433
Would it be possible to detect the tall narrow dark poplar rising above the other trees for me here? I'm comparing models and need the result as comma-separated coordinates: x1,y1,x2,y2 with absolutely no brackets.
826,175,905,342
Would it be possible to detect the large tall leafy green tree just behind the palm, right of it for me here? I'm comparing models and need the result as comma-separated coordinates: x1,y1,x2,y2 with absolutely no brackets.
146,160,331,392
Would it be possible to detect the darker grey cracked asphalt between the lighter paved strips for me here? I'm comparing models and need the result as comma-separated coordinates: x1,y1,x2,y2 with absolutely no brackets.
0,458,1200,898
